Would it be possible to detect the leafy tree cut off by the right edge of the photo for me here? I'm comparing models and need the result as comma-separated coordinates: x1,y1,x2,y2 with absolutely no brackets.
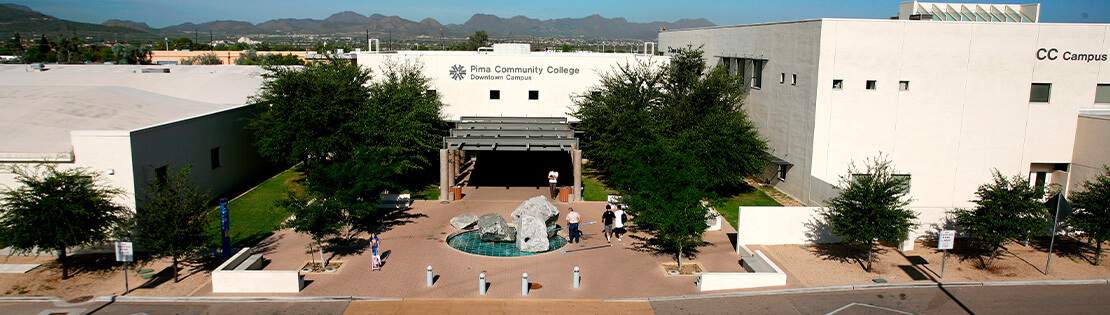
1068,165,1110,265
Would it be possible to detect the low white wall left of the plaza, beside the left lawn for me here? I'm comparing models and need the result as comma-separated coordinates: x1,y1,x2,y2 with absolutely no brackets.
212,248,304,293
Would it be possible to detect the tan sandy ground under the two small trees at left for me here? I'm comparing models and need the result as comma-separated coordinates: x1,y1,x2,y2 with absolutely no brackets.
0,250,211,301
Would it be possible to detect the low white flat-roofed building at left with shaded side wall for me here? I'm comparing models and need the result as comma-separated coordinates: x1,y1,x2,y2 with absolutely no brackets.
0,64,275,210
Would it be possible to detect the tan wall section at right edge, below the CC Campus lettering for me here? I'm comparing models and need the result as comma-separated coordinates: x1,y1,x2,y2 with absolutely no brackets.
1068,115,1110,191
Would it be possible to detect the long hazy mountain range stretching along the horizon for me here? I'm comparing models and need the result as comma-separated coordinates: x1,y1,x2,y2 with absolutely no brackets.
0,3,715,40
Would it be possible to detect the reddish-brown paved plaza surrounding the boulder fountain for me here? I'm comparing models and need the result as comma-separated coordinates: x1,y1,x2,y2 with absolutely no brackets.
195,186,743,299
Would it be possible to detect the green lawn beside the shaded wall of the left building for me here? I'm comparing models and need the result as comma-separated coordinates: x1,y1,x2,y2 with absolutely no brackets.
212,166,304,247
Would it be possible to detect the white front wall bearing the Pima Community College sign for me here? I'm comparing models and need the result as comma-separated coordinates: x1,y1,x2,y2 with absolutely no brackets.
357,51,668,120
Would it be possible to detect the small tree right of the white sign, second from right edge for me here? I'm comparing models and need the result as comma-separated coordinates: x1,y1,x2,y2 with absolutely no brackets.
952,170,1048,268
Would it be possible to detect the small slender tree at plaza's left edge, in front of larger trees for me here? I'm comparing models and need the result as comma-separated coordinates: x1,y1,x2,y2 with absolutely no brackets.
278,192,344,267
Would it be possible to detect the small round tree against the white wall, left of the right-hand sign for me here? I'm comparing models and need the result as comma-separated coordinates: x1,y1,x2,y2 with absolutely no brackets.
823,155,918,272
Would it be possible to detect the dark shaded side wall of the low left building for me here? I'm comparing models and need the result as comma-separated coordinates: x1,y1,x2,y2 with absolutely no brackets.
131,105,272,209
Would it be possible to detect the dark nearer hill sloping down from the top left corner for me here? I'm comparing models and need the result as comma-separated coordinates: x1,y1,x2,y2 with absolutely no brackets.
0,3,158,41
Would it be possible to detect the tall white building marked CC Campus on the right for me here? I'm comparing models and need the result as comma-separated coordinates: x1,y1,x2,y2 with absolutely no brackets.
659,2,1110,209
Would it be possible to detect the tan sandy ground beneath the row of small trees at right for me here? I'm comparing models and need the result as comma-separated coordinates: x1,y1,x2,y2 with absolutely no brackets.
751,237,1110,286
